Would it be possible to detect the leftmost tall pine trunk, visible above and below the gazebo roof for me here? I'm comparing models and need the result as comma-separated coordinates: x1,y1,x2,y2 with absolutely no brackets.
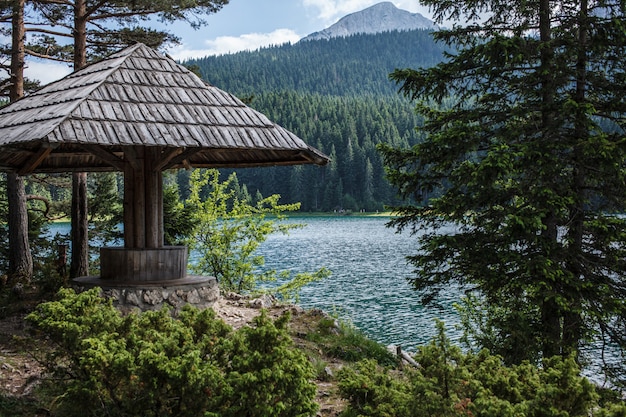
7,0,33,285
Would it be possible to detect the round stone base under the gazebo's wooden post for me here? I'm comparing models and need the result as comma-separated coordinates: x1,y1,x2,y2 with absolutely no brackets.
74,275,220,314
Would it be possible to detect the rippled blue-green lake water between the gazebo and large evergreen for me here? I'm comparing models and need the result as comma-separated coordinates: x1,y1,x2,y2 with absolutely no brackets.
49,215,460,350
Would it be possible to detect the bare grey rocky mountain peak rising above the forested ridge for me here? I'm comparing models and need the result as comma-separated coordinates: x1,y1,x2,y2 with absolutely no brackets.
302,1,439,41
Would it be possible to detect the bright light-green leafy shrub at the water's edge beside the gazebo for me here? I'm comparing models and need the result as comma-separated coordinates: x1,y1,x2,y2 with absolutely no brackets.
185,169,330,301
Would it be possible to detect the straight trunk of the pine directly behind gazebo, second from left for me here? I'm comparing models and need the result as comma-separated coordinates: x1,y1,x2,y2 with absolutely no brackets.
70,0,89,278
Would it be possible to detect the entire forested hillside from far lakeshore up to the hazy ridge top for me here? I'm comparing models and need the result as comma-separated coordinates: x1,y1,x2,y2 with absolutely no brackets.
179,30,443,211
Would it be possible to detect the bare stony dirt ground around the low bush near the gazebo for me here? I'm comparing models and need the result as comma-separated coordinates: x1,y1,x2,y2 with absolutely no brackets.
0,294,345,417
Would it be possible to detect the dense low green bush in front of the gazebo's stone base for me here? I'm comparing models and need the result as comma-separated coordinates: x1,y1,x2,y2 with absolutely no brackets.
28,289,317,417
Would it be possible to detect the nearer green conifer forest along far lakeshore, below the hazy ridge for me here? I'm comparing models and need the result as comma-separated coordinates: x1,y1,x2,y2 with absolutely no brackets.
178,92,418,211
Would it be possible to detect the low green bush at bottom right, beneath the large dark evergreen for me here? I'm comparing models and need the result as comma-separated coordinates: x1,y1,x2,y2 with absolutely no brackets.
338,324,625,417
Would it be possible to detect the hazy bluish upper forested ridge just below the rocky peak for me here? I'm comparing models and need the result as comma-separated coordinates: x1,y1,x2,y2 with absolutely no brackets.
185,30,444,96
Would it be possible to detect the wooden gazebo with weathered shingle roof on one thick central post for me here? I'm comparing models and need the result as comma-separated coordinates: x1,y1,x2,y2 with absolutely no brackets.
0,44,328,283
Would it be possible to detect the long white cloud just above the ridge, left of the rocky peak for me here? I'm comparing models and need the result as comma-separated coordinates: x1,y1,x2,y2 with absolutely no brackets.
168,29,301,60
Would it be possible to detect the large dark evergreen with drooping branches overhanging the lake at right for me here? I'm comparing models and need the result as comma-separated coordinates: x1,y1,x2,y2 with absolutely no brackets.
383,0,626,382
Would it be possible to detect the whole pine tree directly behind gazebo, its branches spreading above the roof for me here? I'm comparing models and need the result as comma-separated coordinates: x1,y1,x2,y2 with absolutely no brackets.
20,0,228,277
